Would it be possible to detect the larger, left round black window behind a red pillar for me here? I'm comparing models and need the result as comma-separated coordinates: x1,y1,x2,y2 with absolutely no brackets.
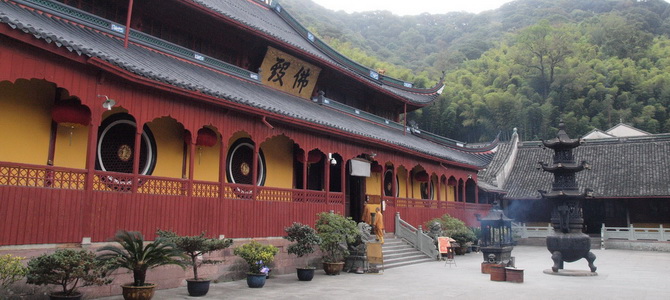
96,114,156,175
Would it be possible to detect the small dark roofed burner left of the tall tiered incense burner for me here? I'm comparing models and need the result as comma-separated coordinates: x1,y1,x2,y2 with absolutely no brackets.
479,203,514,274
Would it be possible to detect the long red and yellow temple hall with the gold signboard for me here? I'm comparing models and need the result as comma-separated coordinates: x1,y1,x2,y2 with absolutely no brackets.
0,0,497,272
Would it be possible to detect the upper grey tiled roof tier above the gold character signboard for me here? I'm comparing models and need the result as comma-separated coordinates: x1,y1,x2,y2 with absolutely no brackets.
194,0,438,105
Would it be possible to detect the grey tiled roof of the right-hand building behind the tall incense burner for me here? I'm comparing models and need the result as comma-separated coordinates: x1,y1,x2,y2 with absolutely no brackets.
496,135,670,199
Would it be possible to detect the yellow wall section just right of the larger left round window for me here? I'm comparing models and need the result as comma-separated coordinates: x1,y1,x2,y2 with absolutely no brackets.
148,118,185,178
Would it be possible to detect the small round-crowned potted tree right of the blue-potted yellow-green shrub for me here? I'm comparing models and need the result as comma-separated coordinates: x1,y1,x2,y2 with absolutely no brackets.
284,222,321,281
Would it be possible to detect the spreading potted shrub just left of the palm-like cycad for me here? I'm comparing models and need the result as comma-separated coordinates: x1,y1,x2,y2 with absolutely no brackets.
26,249,111,299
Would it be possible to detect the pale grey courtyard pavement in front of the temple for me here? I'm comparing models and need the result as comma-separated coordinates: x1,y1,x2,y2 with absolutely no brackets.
100,246,670,300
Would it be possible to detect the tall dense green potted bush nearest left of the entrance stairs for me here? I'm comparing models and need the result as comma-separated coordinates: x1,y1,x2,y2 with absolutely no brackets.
315,212,359,275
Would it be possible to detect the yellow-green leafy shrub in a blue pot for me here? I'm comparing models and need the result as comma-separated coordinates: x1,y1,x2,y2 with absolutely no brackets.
233,241,279,288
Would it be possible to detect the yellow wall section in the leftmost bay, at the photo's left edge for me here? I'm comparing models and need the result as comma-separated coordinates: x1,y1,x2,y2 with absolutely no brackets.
0,80,56,165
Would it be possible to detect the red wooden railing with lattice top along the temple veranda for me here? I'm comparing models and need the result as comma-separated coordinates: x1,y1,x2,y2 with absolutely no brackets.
0,162,490,245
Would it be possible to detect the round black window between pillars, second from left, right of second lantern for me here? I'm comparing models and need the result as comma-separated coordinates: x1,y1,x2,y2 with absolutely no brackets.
226,138,265,186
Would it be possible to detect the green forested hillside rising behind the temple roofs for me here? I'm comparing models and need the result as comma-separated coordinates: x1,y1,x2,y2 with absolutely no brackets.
279,0,670,142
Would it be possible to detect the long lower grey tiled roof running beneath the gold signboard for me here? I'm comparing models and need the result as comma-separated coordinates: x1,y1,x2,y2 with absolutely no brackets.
0,1,488,166
